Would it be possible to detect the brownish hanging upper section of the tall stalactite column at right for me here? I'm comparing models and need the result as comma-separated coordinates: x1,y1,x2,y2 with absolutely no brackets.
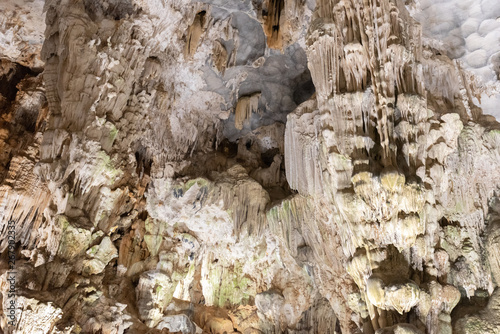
307,0,427,166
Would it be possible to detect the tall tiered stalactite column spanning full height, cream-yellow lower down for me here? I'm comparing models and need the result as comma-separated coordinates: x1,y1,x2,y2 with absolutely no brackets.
296,0,450,333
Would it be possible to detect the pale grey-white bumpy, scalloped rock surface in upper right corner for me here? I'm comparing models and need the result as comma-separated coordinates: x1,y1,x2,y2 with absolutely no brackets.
406,0,500,119
